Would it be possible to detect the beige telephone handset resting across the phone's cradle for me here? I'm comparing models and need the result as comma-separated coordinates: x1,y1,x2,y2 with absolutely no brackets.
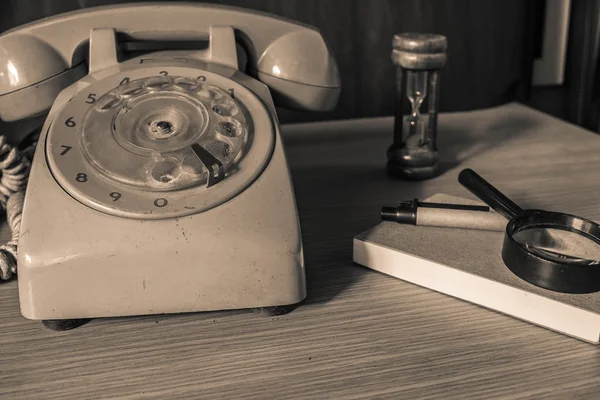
0,3,340,121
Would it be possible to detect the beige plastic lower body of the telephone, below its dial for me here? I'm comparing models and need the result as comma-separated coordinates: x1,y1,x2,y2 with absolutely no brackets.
18,80,306,320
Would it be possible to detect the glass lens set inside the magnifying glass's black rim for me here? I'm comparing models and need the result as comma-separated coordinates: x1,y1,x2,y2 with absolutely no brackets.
513,227,600,265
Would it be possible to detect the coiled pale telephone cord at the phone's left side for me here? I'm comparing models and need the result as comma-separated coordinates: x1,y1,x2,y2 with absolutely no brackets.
0,135,31,281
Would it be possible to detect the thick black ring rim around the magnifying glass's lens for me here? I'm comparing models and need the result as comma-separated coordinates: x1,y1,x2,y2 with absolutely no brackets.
502,210,600,293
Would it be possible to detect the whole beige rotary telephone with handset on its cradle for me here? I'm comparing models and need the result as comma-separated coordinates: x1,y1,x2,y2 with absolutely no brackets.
0,3,340,329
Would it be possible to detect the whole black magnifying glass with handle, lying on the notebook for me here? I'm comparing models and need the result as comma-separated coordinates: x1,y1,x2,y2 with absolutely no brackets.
458,168,600,293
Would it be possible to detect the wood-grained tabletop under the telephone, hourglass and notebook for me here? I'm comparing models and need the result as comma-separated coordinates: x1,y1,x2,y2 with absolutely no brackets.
0,104,600,399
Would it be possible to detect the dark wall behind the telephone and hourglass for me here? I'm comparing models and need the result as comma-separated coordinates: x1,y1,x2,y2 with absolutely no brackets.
0,0,599,130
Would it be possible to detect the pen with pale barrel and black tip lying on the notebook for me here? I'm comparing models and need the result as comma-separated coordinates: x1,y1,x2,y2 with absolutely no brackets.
381,199,508,232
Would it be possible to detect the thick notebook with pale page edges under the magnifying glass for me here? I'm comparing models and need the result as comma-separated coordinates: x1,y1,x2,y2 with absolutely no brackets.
353,194,600,344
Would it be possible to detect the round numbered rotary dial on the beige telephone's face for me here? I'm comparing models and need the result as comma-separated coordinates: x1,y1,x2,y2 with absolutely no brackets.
46,67,274,218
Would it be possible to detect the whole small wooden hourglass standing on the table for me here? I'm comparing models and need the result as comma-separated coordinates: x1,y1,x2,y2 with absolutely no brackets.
387,33,447,180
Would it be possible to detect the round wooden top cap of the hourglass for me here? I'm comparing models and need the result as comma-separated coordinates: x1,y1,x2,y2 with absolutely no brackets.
392,32,448,70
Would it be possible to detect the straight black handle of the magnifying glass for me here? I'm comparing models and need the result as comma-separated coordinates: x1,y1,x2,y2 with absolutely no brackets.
458,168,523,220
